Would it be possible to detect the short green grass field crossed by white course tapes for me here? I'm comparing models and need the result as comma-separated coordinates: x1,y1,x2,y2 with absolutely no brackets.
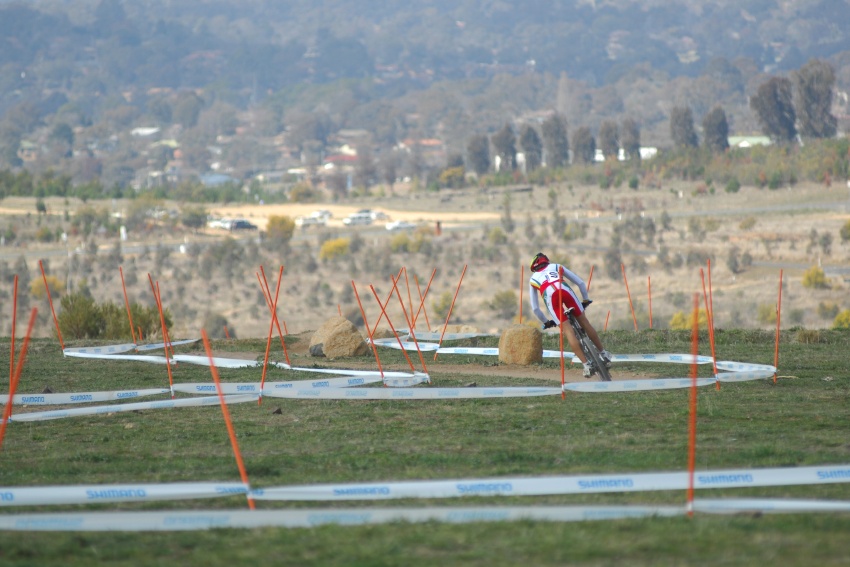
0,330,850,566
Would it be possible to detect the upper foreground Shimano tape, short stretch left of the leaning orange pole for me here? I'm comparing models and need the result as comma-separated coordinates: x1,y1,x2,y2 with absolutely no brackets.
0,482,249,507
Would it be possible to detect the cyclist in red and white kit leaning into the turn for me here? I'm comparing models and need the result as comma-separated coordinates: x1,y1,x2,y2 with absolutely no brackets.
528,252,611,378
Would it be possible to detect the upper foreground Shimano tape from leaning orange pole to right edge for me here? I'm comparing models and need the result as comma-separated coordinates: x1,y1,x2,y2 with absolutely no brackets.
252,465,850,500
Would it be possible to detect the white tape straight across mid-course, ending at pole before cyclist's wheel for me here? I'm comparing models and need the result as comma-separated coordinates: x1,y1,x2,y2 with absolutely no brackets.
263,387,561,400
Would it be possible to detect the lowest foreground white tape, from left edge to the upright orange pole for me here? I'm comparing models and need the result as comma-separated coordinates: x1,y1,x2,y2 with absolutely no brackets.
0,506,685,532
